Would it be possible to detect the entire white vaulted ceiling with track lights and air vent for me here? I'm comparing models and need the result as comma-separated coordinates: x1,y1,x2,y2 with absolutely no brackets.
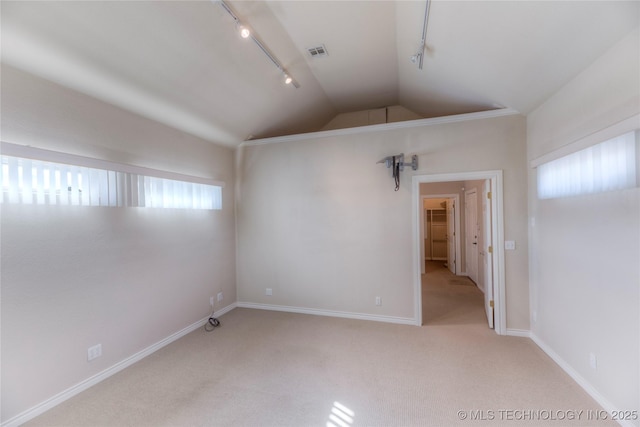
0,0,640,146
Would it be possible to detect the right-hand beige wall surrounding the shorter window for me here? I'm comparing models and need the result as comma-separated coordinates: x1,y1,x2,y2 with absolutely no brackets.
527,29,640,425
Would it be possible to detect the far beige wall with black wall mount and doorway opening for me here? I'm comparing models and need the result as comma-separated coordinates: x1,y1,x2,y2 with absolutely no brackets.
237,111,529,329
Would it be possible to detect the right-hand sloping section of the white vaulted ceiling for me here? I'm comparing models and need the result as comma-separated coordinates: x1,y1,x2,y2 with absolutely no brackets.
396,1,640,117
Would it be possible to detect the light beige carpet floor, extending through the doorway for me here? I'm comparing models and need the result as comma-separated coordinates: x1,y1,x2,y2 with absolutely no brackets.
27,268,615,427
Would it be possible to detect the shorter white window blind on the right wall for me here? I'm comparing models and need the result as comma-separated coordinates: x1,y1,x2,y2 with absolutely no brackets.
537,131,638,199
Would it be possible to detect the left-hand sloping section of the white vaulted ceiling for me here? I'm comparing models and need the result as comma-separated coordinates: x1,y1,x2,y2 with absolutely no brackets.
2,2,336,145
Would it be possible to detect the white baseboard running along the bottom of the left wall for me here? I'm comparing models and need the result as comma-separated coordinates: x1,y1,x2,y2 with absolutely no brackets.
0,303,236,427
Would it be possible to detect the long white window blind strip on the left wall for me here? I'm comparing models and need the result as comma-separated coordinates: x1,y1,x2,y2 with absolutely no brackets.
0,146,222,210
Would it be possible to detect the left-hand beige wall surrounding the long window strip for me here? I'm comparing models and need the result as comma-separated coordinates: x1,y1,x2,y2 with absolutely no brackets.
1,67,235,422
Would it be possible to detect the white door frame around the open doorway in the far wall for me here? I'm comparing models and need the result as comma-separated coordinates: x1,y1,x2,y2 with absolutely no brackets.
411,170,507,335
